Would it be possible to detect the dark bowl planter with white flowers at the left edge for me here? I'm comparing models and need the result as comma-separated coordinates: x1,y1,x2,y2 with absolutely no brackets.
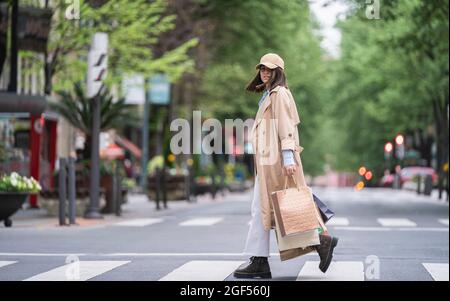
0,172,41,227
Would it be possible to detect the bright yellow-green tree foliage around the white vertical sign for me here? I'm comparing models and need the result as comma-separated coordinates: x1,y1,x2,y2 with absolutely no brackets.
47,0,197,93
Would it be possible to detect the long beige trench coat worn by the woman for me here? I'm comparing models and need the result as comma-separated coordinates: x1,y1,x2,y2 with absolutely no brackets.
251,86,311,260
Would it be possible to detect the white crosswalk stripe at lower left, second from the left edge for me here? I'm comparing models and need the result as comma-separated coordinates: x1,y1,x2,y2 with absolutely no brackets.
24,261,130,281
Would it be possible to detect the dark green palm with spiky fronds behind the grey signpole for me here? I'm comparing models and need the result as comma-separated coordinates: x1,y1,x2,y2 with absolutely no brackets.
50,82,132,159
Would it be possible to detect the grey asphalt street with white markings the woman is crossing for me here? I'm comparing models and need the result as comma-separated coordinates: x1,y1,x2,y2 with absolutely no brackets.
0,188,449,281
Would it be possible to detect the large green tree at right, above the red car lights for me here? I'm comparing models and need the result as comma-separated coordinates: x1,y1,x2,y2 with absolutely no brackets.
328,0,448,191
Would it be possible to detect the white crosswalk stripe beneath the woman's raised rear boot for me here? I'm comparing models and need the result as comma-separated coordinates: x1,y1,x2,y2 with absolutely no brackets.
297,261,364,281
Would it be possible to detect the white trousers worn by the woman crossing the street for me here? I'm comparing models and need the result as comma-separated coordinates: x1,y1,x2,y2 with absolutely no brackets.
244,176,270,257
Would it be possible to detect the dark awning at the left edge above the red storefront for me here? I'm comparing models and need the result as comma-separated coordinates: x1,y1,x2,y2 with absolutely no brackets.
0,92,47,115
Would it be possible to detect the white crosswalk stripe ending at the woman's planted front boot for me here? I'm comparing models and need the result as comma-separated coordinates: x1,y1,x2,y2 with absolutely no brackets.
159,260,245,281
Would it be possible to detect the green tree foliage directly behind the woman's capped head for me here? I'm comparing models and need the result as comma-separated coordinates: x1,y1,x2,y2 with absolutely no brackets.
194,0,326,174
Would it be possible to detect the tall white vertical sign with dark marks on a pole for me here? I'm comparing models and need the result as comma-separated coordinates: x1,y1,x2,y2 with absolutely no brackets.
87,32,108,98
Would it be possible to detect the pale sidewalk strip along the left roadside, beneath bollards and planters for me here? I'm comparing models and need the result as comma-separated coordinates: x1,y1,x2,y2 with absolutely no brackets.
0,191,251,229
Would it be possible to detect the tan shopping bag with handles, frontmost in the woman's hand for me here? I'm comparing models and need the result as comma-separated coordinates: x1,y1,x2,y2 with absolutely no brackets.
272,176,322,236
